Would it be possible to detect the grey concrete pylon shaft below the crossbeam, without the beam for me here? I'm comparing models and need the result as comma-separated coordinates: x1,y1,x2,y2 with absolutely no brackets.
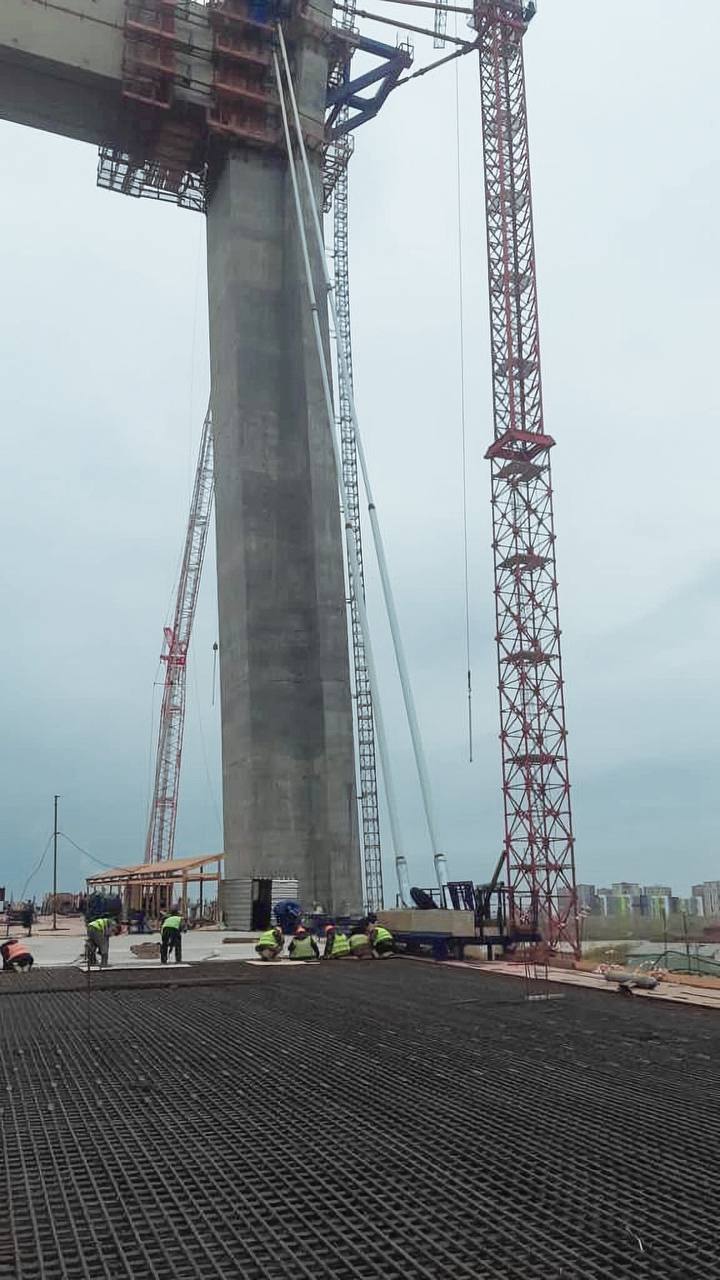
202,17,361,913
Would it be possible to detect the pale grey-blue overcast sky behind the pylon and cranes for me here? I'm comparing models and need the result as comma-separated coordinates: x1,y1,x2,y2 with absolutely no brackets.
0,0,720,892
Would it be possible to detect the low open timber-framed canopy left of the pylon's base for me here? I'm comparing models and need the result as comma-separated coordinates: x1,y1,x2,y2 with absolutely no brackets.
86,854,225,919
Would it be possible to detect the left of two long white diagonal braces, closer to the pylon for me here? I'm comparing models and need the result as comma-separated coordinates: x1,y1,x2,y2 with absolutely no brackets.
273,50,409,906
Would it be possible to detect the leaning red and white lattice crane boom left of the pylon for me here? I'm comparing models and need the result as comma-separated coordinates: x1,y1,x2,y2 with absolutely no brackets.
145,410,214,863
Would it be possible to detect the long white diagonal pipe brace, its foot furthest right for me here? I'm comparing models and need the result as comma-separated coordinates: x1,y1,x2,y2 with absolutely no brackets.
278,23,441,858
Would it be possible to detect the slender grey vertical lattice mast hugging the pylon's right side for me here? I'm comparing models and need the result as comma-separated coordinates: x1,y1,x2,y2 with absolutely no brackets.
325,12,383,910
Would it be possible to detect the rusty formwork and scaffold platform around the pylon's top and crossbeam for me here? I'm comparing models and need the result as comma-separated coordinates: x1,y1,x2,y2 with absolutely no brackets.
97,0,285,212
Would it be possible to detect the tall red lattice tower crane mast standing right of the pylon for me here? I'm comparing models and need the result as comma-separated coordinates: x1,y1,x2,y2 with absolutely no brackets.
475,0,578,950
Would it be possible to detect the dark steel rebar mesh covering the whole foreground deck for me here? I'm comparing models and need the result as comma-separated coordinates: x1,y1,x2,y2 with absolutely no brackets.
0,959,720,1280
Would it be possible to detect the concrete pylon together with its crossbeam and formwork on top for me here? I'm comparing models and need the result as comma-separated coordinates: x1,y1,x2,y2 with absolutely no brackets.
0,0,361,923
